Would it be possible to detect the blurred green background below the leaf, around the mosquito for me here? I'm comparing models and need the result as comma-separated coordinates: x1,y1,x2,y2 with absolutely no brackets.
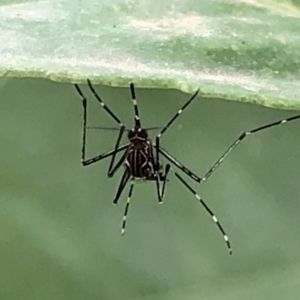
0,78,300,300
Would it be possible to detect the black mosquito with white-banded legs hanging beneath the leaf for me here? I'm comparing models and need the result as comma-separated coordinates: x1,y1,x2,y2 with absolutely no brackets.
75,80,300,254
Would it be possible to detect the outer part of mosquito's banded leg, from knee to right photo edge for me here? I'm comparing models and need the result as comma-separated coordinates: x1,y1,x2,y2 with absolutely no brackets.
201,115,300,182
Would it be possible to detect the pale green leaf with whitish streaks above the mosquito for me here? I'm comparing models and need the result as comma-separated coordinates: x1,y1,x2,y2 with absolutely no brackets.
0,0,300,109
